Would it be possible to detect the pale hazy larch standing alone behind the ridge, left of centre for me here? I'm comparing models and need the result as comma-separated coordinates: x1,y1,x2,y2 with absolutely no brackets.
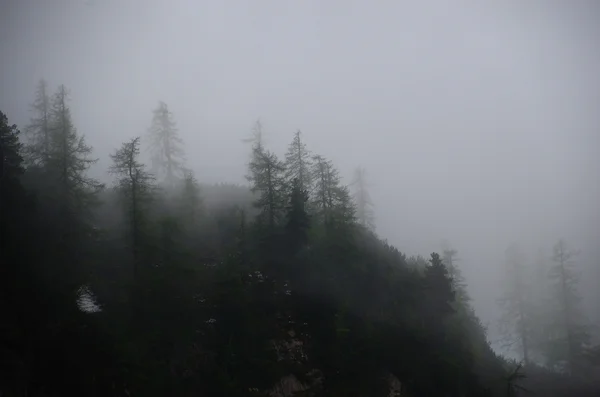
148,101,185,187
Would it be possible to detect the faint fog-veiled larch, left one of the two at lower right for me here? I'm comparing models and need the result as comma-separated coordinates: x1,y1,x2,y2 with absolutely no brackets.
500,244,533,365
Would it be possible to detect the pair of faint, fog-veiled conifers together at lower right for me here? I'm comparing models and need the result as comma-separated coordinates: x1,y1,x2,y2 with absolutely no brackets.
500,239,597,376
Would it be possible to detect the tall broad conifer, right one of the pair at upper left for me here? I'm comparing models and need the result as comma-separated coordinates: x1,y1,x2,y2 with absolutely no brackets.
43,85,104,293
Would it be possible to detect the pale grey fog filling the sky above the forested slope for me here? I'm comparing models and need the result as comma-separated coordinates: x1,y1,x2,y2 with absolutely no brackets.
0,0,600,352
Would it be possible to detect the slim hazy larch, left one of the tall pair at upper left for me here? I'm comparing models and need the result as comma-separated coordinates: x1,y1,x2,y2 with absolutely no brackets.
25,79,52,165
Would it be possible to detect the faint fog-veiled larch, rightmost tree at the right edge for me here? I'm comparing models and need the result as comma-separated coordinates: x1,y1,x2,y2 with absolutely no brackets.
548,239,589,374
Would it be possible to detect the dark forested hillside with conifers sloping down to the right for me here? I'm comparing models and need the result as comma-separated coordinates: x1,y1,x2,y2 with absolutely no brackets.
0,87,598,397
